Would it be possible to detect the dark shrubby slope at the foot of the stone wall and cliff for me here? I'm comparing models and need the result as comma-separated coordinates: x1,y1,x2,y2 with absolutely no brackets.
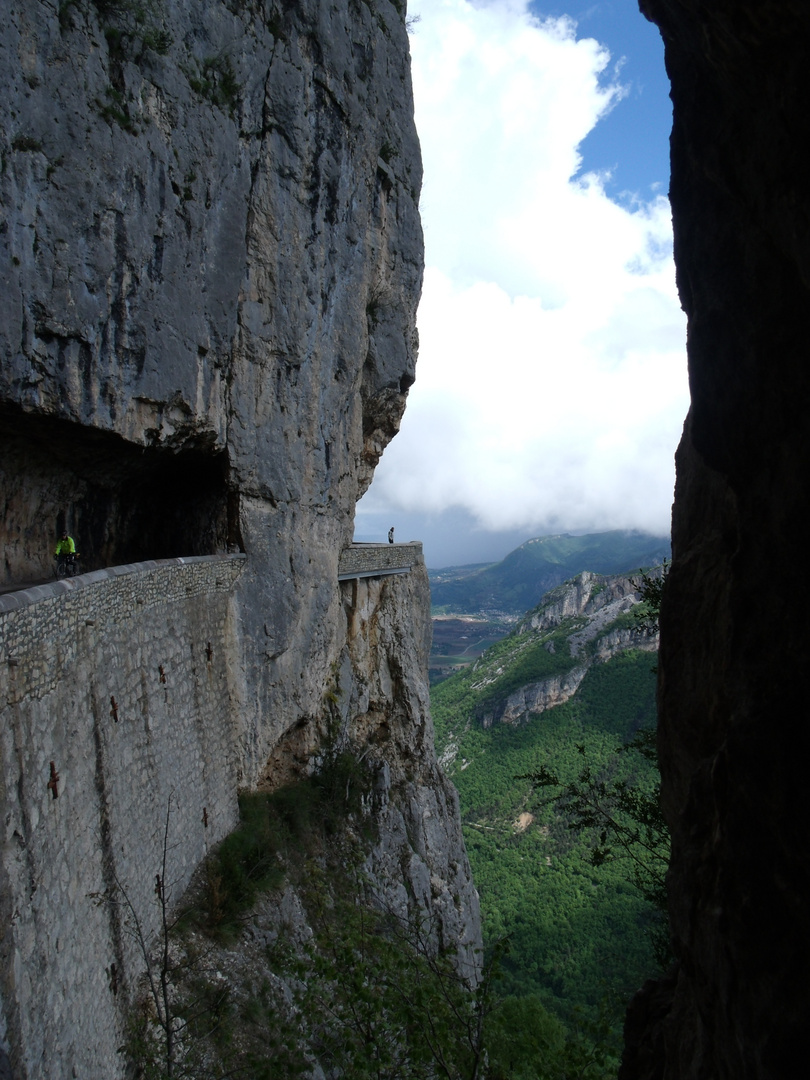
120,754,616,1080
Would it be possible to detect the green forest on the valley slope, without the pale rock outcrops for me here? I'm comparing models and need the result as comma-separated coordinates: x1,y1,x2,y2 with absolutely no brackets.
432,639,660,1062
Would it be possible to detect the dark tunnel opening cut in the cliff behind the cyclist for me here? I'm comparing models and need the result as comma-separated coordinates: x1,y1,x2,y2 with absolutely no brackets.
0,406,241,584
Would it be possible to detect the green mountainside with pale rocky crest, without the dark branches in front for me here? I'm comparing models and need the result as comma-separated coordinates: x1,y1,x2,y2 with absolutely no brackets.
431,570,657,1023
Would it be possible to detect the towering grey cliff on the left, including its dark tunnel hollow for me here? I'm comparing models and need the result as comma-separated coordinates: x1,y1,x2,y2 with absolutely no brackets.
0,0,422,783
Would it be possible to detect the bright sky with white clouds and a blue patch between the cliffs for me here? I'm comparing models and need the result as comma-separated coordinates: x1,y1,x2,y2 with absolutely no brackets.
355,0,688,567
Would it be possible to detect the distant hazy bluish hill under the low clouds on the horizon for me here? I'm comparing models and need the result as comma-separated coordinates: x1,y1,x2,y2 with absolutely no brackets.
429,530,670,615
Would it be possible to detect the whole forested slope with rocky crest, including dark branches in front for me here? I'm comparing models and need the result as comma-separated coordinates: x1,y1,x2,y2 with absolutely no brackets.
431,548,667,1080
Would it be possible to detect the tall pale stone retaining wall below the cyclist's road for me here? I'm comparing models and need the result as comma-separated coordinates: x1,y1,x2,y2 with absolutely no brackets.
0,556,244,1080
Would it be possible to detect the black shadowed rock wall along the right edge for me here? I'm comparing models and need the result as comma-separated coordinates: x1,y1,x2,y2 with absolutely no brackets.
622,0,810,1080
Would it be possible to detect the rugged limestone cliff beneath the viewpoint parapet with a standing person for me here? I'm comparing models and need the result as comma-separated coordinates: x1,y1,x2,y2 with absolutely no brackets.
341,565,482,975
